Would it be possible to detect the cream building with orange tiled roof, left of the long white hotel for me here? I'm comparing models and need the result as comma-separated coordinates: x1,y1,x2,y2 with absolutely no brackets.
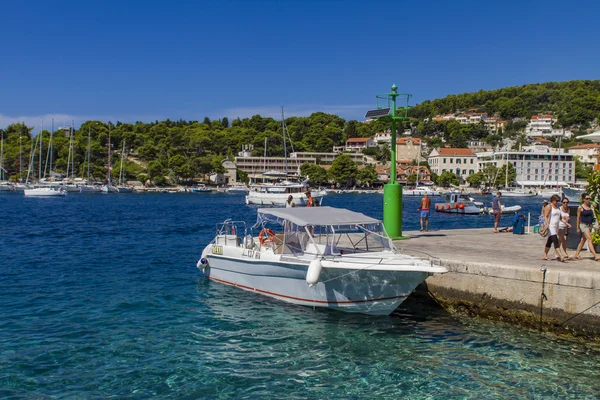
427,147,479,180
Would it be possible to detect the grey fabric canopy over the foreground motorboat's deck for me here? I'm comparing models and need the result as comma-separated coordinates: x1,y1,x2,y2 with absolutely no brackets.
256,207,381,226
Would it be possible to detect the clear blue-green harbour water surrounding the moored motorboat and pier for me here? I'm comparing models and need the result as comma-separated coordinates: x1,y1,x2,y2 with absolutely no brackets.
0,194,600,399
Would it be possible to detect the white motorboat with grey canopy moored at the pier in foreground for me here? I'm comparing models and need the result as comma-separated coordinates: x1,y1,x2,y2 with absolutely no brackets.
196,207,447,315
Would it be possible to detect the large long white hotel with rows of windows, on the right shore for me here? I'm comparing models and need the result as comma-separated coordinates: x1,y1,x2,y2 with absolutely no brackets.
477,149,575,187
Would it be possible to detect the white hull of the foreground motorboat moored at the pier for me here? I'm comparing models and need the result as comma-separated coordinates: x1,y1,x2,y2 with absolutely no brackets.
199,256,428,315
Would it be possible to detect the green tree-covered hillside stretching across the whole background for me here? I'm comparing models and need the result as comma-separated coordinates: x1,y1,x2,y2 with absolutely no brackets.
2,80,600,185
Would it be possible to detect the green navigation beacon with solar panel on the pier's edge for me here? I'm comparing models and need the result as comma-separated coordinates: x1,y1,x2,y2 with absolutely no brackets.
365,84,412,239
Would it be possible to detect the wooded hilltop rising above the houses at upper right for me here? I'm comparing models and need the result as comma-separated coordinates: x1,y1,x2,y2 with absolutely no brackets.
409,80,600,127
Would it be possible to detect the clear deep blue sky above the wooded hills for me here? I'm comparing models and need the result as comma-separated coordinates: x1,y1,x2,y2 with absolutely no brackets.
0,0,600,130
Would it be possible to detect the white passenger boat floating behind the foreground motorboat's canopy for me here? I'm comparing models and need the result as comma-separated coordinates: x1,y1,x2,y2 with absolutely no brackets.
246,181,327,207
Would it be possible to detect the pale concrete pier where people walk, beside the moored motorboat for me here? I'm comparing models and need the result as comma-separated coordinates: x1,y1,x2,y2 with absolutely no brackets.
395,227,600,339
